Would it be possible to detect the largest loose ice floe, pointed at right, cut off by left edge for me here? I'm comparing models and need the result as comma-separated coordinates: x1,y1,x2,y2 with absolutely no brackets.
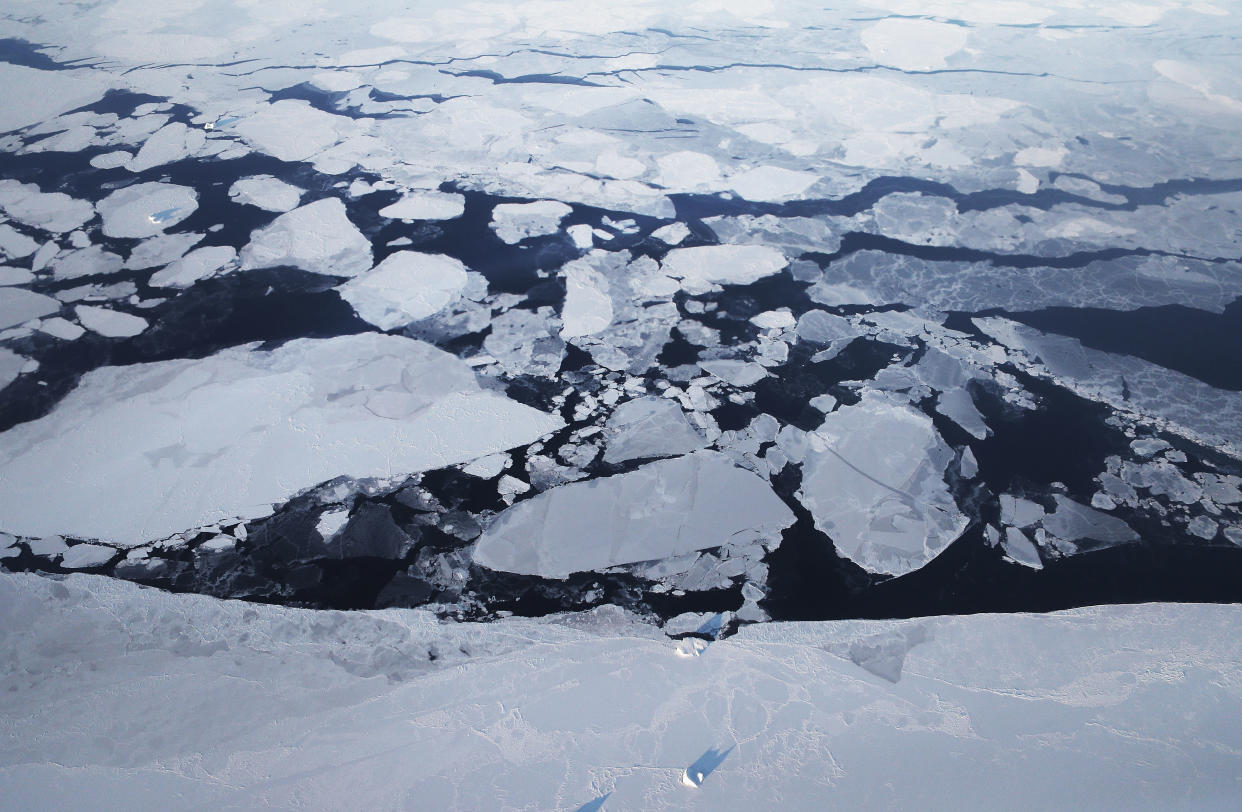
0,333,563,546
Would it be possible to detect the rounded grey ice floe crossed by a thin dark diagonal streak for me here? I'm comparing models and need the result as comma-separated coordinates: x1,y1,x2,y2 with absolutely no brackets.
797,392,968,575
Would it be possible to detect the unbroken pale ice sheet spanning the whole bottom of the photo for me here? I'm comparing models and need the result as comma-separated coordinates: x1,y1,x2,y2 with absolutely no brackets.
0,574,1242,811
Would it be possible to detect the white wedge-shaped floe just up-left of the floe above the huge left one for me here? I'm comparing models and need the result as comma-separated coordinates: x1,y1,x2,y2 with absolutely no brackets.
241,197,371,277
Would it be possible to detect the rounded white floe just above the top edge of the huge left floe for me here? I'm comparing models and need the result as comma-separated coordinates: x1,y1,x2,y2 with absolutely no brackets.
337,251,467,330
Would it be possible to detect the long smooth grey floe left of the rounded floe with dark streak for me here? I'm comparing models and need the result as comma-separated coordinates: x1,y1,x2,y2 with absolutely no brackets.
474,451,794,579
